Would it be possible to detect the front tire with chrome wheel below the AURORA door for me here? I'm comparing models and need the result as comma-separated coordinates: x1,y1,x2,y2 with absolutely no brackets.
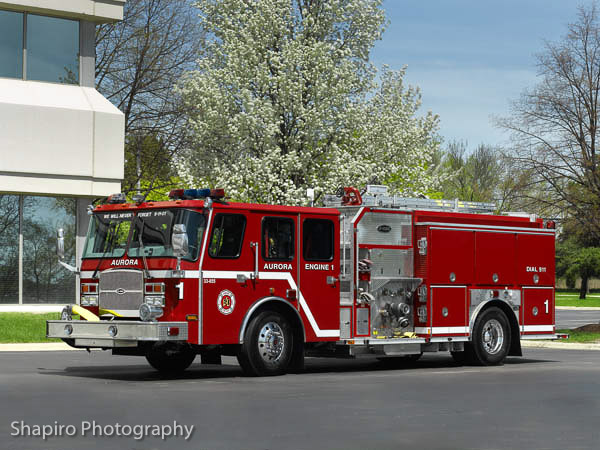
237,311,294,376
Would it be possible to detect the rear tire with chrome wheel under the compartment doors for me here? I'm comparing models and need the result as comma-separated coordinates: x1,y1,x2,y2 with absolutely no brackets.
471,307,510,366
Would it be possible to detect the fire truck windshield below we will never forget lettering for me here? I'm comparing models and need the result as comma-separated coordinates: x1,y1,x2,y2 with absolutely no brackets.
83,209,206,260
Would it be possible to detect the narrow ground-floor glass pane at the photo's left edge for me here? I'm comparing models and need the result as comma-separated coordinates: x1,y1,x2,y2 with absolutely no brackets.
0,195,19,303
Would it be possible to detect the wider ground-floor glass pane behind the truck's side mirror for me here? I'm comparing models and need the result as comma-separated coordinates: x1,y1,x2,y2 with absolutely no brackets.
22,196,76,303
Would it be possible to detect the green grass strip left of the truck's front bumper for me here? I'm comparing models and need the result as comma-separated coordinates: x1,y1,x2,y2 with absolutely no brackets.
0,313,61,344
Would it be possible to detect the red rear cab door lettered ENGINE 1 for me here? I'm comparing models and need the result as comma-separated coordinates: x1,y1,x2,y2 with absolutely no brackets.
298,214,340,340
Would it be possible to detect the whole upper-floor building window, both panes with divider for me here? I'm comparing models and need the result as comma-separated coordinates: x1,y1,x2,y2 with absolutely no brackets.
0,11,79,84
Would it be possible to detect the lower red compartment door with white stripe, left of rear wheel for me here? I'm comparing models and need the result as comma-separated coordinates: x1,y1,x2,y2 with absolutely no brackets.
431,286,469,336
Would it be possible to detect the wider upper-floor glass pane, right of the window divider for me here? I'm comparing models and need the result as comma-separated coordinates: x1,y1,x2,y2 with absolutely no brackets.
27,14,79,84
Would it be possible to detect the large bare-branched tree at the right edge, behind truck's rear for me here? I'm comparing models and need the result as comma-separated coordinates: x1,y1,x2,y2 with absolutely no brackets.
498,2,600,238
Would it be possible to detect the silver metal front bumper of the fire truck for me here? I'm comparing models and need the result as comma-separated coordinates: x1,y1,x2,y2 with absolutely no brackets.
46,320,188,348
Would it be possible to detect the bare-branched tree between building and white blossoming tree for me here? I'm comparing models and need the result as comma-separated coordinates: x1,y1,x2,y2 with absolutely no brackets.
96,0,202,192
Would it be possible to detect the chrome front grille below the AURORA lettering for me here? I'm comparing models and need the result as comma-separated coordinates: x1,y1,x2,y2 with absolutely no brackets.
99,269,144,317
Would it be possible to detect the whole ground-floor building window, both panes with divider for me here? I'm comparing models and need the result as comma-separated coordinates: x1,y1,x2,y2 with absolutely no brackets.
0,195,76,304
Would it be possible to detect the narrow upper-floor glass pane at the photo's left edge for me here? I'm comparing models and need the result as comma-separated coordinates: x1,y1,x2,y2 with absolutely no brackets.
0,11,23,78
